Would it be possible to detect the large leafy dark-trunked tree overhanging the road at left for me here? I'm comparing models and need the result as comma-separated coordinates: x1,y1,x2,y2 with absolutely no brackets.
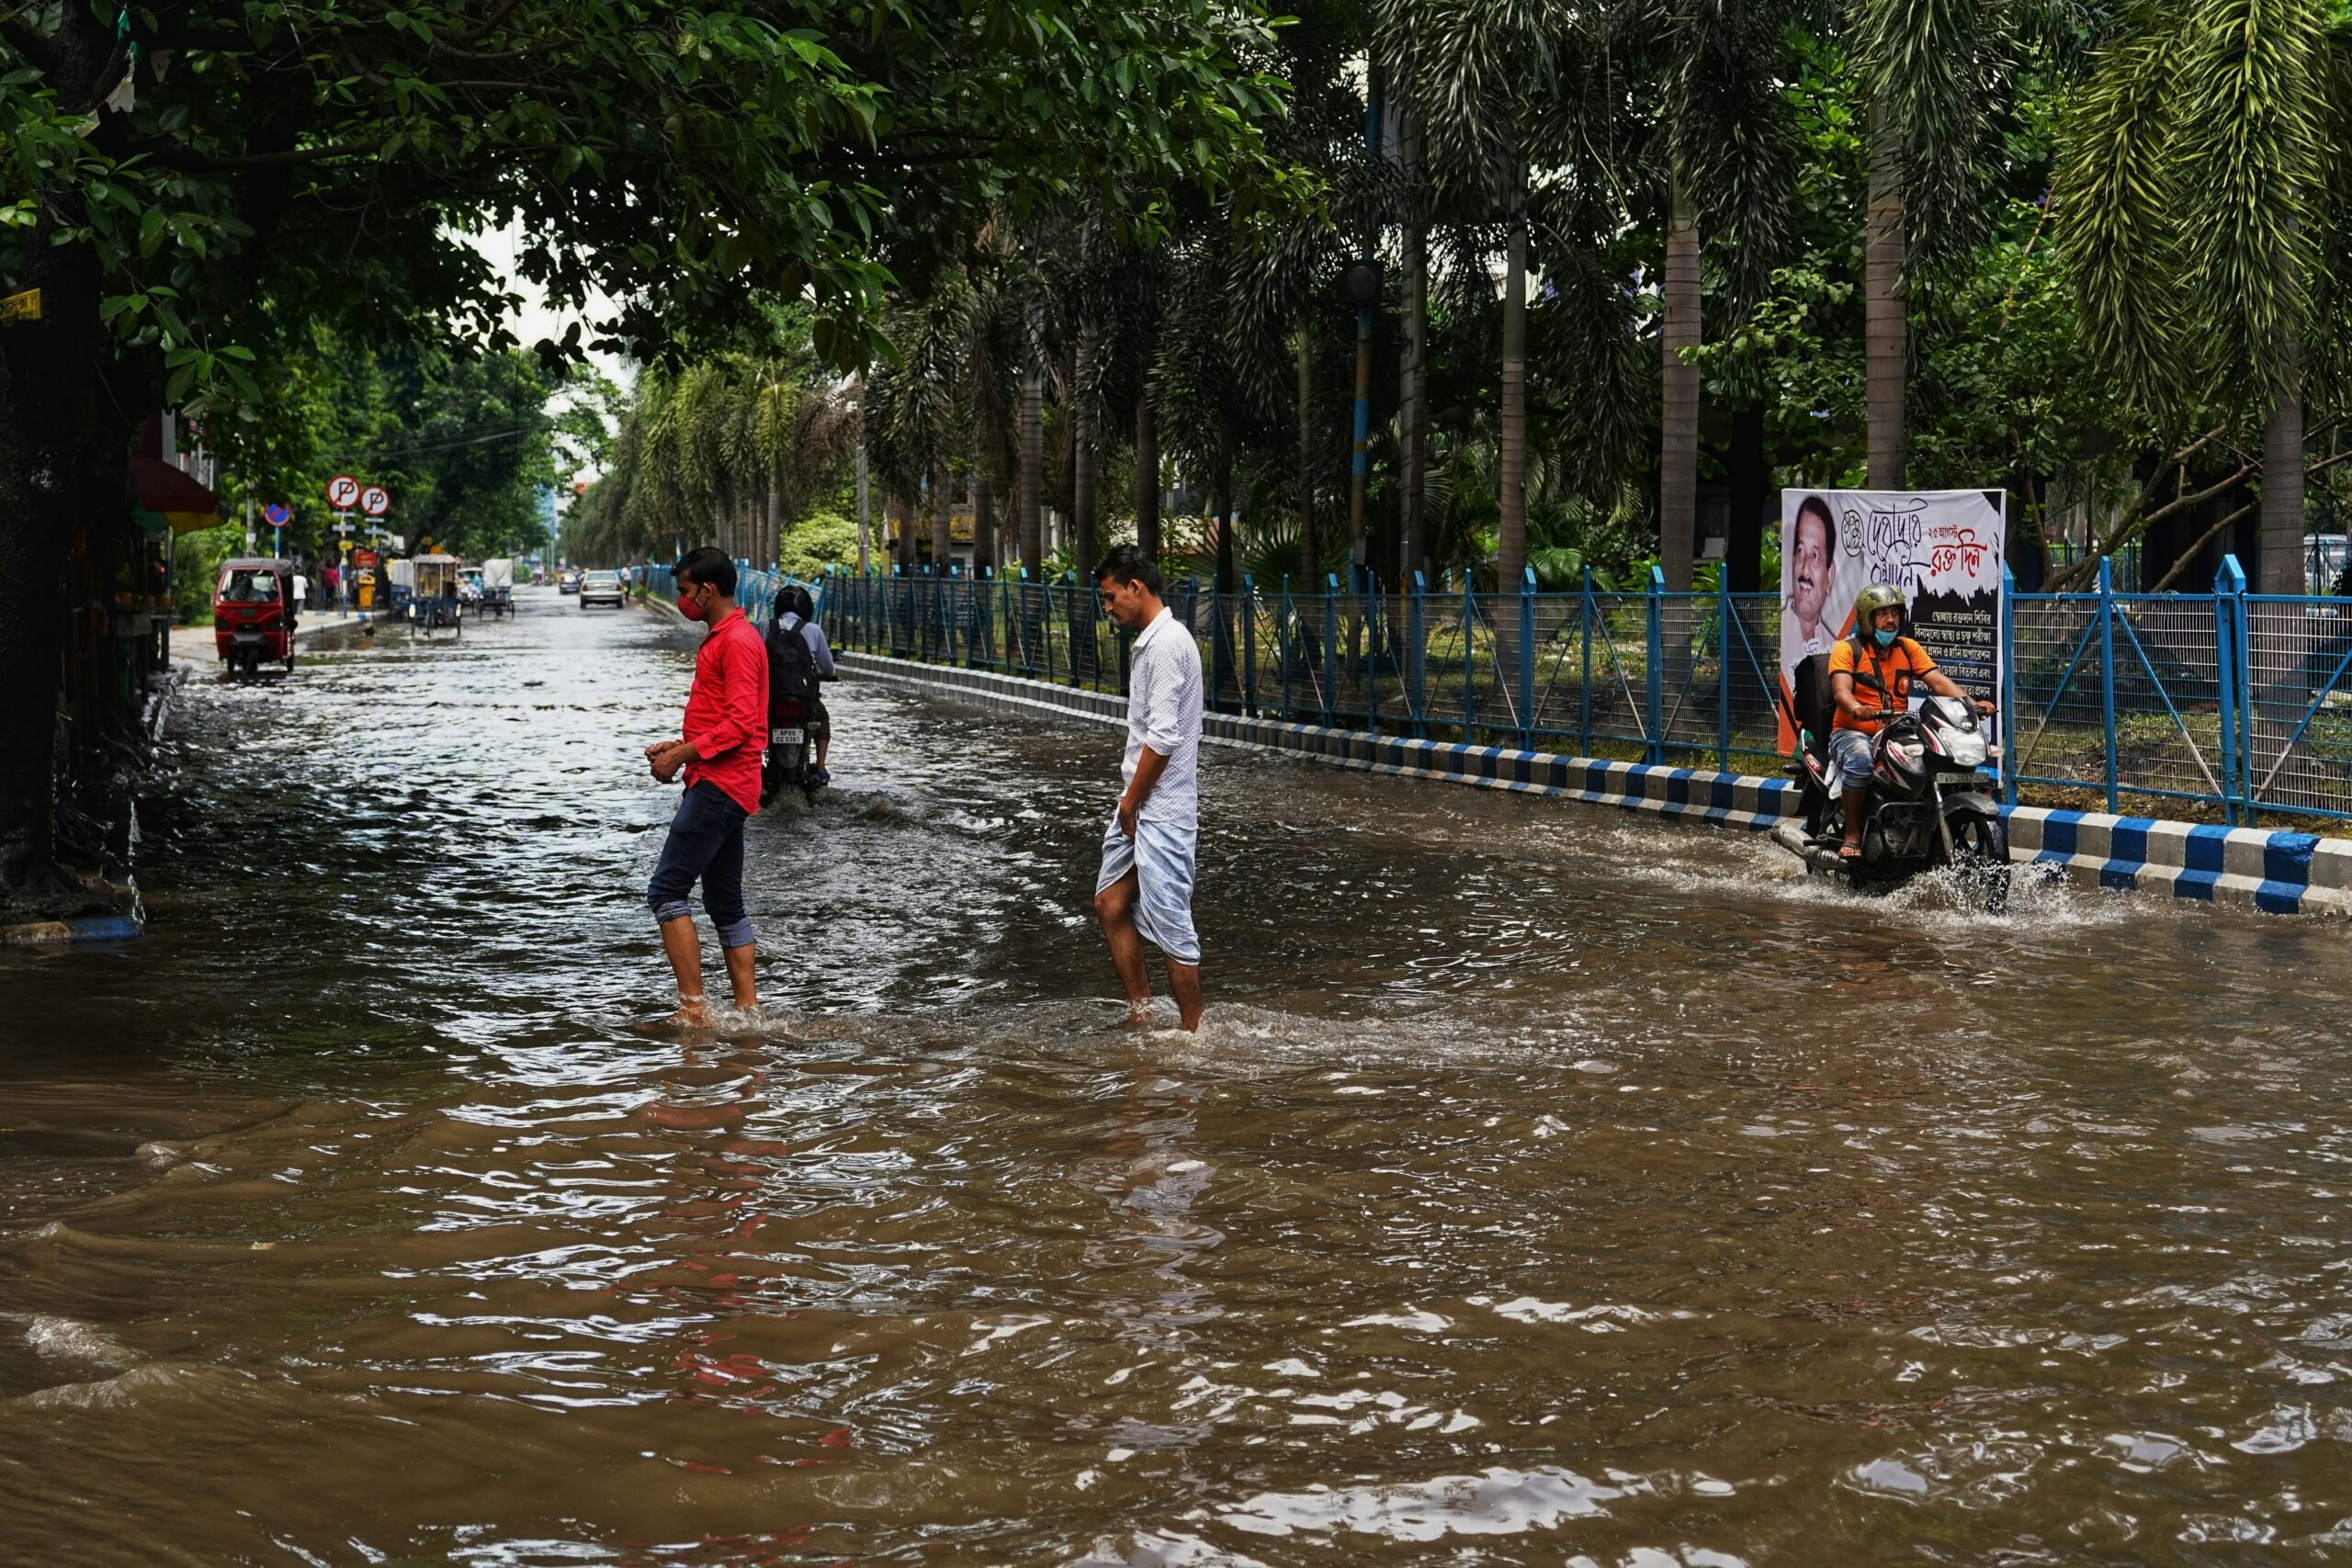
0,0,1282,884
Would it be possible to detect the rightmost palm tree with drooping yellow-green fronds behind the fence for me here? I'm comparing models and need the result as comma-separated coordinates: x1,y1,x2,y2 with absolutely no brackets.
2055,0,2352,594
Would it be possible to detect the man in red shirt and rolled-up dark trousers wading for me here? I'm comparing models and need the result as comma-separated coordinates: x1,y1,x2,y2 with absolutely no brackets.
644,546,767,1027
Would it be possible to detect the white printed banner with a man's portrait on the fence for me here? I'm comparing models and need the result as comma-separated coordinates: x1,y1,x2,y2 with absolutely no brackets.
1781,489,2008,752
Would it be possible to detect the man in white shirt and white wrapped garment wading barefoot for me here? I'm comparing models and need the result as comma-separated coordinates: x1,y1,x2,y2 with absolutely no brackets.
1093,546,1202,1030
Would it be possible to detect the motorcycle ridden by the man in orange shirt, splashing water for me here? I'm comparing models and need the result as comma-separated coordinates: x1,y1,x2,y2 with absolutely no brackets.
1771,696,2008,915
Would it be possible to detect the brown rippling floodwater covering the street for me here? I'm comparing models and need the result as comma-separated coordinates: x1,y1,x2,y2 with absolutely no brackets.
0,592,2352,1568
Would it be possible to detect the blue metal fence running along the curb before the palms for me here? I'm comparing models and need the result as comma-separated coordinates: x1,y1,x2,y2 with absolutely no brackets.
790,559,2352,823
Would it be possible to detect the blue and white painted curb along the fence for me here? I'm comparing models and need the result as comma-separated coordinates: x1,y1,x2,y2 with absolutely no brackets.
835,653,2352,915
